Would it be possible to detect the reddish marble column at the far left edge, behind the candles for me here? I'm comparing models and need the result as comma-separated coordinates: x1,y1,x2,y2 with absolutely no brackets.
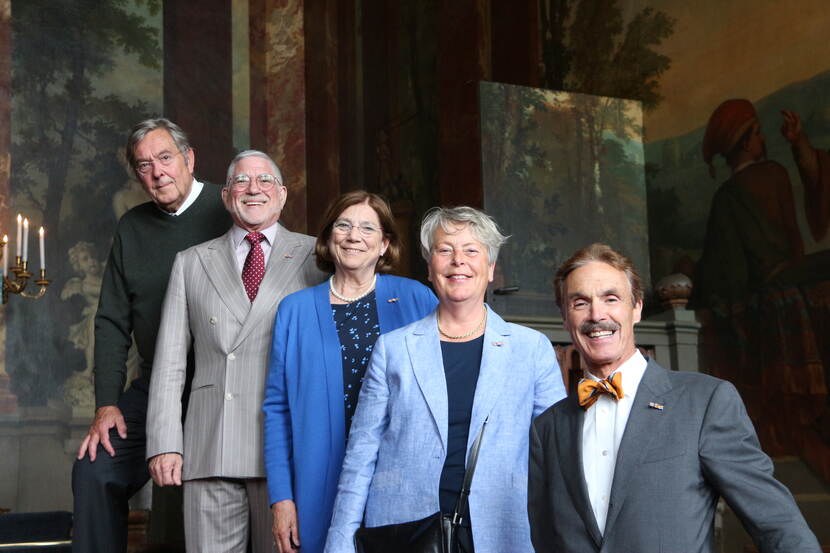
0,0,17,415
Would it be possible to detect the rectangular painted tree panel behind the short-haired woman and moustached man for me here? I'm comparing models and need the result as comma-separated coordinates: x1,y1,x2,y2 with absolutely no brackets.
480,83,648,315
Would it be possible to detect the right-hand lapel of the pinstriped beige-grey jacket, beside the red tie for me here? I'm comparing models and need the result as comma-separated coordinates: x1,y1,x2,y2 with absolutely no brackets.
233,224,305,348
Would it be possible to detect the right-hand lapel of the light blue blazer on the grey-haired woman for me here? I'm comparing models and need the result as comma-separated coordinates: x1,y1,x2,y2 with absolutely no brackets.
467,307,512,451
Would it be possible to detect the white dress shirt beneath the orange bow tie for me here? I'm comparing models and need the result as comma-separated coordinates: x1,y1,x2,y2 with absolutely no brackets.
582,350,647,534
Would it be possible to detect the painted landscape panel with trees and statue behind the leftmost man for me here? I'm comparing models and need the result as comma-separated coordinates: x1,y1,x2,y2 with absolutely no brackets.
6,0,162,409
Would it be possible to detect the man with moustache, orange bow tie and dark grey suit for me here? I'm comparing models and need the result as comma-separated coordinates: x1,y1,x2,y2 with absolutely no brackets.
528,244,820,553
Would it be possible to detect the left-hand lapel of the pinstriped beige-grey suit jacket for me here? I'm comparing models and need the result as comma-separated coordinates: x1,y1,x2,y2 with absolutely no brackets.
196,231,250,324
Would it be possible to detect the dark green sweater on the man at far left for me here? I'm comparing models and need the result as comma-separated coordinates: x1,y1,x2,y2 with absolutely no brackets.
95,184,231,408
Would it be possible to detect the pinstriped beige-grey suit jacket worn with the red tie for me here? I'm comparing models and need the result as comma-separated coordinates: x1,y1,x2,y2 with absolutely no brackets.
147,226,323,480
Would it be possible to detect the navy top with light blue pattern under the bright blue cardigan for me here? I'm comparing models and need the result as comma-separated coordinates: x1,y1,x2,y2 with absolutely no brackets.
331,290,380,438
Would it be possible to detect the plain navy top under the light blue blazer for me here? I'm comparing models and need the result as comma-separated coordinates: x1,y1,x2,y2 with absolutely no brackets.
438,335,484,526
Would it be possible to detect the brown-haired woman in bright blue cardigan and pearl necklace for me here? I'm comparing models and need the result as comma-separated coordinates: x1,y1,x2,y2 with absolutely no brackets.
263,190,437,553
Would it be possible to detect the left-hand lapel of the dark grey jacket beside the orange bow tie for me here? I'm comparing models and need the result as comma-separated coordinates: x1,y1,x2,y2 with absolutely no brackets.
556,394,602,547
